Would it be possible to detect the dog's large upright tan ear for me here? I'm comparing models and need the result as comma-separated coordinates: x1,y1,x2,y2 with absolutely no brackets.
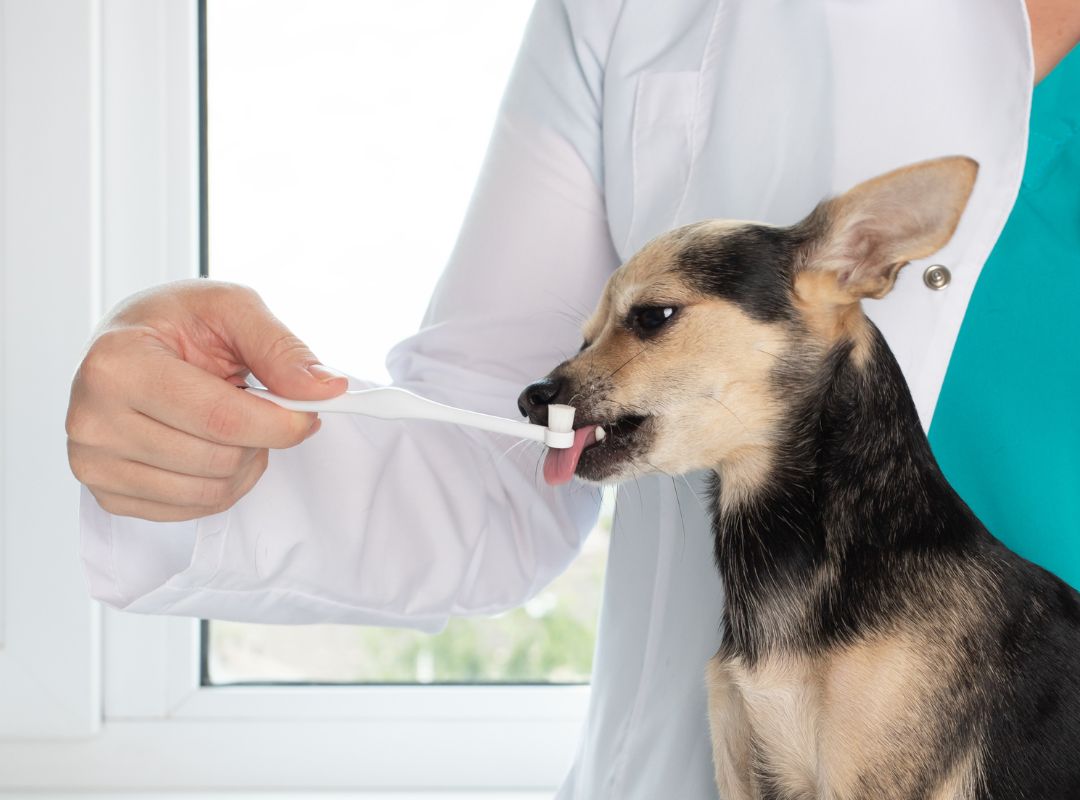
796,155,978,301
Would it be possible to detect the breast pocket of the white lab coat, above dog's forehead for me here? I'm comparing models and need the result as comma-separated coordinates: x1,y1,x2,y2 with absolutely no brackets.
623,71,700,253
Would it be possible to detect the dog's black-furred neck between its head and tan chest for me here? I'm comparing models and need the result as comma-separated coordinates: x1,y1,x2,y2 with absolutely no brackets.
713,321,985,662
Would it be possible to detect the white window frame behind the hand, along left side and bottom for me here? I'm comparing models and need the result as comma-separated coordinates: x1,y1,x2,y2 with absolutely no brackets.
0,0,589,796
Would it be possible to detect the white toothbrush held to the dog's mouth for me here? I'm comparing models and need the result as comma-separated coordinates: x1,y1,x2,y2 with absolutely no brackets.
247,387,583,449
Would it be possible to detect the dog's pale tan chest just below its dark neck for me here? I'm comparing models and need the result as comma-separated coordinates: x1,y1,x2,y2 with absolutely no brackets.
710,640,934,800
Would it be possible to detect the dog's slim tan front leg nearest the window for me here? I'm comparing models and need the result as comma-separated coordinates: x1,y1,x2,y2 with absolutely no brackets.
705,655,757,800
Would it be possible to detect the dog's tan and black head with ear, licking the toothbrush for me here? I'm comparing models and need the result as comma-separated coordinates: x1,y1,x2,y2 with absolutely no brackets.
518,157,977,496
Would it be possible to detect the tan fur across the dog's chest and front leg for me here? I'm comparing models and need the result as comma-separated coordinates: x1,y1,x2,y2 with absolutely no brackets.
706,629,980,800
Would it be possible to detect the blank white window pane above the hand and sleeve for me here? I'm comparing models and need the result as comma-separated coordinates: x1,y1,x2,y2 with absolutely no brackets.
206,0,531,381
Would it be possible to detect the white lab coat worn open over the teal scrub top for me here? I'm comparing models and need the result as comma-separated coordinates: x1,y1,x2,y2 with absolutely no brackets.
82,0,1032,800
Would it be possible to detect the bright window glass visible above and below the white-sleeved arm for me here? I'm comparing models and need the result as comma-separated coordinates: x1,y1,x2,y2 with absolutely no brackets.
203,0,609,683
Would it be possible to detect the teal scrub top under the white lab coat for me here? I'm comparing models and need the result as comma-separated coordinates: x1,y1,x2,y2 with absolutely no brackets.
930,46,1080,588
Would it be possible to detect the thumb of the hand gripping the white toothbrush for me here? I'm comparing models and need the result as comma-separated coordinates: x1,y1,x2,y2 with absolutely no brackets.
226,296,349,399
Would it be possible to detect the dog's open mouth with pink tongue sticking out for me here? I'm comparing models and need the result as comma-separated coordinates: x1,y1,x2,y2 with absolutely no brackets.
543,415,652,486
